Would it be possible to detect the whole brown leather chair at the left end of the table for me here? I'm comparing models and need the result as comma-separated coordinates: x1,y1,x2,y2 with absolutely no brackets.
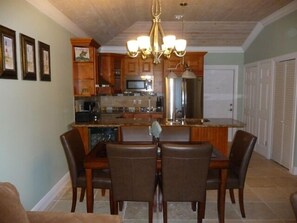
60,129,112,213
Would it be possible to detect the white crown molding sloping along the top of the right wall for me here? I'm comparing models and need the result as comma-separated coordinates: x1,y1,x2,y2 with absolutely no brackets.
242,0,297,51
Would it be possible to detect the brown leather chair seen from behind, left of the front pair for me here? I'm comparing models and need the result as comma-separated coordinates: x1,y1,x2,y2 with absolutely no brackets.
106,143,157,223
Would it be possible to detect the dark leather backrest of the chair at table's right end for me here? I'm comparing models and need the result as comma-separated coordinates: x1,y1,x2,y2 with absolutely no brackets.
229,130,257,187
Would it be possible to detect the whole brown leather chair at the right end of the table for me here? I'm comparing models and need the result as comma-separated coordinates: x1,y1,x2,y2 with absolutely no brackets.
207,130,257,218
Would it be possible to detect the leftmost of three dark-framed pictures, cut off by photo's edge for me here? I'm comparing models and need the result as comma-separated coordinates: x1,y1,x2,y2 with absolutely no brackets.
0,25,18,79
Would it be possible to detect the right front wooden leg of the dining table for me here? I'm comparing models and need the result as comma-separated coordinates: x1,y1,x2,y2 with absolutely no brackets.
218,169,228,223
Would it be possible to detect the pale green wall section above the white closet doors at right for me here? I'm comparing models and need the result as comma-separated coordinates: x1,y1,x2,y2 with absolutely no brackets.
244,11,297,64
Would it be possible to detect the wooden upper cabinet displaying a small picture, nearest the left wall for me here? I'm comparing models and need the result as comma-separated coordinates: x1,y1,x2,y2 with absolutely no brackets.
71,38,100,96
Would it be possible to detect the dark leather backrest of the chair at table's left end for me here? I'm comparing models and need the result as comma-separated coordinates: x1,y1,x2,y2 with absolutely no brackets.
60,129,86,186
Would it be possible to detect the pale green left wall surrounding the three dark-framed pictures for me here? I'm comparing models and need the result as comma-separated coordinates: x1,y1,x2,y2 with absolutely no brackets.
0,0,74,210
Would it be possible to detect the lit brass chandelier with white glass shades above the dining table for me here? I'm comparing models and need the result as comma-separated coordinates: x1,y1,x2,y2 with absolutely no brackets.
127,0,187,64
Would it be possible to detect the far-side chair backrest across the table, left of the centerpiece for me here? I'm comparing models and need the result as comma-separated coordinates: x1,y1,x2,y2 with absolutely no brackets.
121,125,153,142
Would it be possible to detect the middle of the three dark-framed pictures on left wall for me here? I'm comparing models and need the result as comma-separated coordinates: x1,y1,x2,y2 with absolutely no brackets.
20,34,36,80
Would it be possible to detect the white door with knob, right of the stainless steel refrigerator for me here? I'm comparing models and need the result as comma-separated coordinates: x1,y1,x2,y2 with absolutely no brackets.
203,66,237,141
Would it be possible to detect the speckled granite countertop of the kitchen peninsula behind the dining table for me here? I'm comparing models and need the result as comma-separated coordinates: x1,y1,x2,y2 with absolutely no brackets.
72,118,245,128
